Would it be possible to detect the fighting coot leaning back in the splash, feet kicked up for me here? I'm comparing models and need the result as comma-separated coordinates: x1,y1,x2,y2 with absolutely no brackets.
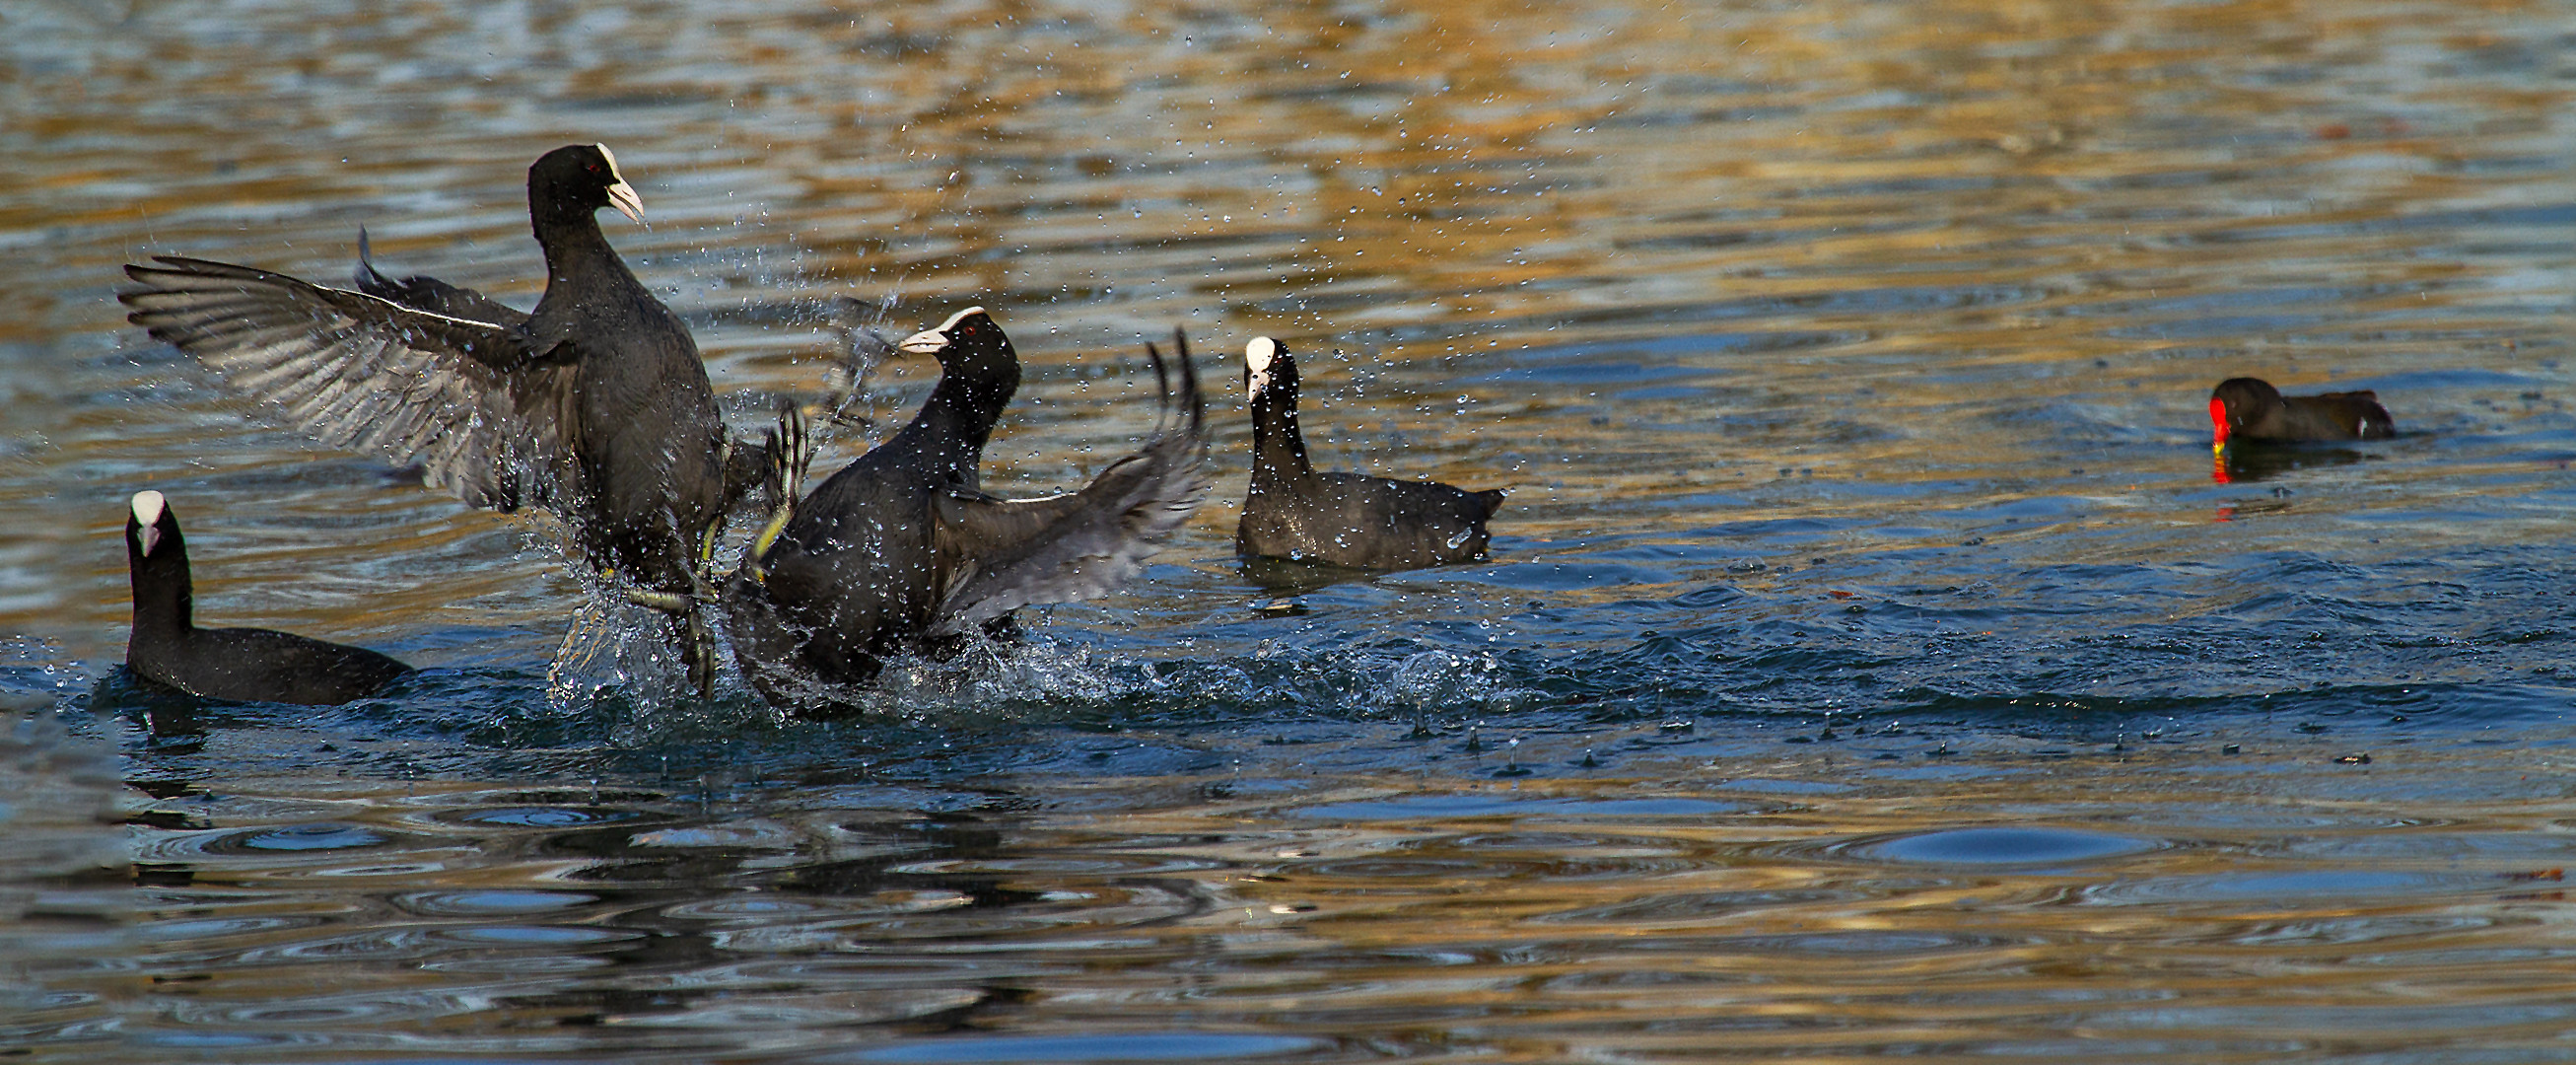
724,307,1208,704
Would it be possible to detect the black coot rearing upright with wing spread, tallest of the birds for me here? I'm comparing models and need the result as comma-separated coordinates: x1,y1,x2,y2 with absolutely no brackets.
118,144,768,686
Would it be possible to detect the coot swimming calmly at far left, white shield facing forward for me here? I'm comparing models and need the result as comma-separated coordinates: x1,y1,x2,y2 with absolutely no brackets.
126,492,412,704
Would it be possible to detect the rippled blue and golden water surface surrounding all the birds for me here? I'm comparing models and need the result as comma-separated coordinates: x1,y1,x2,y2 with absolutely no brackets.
0,0,2576,1062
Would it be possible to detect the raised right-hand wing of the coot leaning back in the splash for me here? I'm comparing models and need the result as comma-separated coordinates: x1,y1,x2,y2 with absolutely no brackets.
930,334,1211,632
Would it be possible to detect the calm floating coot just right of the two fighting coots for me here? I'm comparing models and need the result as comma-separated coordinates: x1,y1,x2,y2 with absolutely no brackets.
1234,338,1501,570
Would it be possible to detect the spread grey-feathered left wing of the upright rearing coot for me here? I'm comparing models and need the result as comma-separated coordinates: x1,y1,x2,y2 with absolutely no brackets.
116,255,580,511
